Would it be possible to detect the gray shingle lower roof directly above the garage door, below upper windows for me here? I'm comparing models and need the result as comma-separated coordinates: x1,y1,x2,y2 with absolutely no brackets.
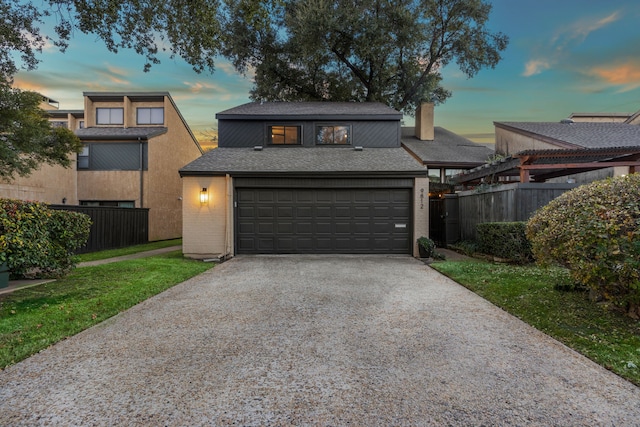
180,147,426,176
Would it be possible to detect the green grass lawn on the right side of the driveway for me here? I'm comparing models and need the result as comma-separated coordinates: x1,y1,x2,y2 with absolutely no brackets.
431,260,640,386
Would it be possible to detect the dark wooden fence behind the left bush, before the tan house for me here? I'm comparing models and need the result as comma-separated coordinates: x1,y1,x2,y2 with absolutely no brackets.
49,205,149,254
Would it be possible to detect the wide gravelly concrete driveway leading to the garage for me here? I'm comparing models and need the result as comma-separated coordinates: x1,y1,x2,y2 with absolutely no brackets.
0,255,640,426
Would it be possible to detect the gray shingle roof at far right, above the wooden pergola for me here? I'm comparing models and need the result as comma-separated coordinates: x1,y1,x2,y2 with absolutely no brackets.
494,122,640,148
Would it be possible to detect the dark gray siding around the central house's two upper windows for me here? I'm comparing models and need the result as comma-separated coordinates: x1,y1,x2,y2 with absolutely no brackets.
218,120,400,148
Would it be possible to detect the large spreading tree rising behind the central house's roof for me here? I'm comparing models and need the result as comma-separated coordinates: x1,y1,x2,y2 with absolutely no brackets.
224,0,508,114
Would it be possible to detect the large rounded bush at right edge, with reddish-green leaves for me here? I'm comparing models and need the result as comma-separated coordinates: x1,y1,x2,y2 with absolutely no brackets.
527,174,640,317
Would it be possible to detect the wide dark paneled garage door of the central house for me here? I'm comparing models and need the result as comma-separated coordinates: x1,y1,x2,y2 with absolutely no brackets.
236,188,412,254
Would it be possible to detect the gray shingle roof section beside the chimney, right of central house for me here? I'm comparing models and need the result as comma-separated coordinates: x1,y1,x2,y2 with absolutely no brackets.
402,126,493,167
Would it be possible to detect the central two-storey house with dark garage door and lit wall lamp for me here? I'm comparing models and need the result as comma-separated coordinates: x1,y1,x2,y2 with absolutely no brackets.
180,102,429,258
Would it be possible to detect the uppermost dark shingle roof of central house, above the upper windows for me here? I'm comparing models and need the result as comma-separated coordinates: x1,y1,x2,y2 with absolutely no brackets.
216,102,402,121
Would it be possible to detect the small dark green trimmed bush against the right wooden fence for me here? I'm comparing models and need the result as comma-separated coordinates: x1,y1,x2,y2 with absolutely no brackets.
476,222,533,263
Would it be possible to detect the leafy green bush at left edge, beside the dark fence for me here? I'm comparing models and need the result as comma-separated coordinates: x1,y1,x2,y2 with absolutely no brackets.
0,199,91,277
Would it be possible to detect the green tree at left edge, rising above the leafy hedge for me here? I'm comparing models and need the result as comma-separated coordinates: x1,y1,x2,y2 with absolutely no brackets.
0,82,82,180
